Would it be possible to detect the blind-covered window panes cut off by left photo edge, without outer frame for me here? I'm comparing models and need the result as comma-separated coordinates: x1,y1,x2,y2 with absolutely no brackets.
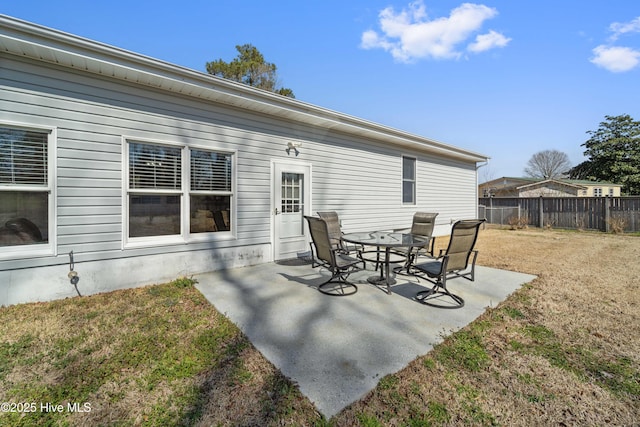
0,125,52,252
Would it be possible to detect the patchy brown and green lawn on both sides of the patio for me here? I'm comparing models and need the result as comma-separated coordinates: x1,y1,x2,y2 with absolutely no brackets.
0,229,640,426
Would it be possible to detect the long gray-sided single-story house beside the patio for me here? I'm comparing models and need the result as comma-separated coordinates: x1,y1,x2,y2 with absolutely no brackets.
0,15,487,305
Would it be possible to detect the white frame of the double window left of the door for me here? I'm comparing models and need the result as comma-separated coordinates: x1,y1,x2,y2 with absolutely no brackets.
122,136,237,249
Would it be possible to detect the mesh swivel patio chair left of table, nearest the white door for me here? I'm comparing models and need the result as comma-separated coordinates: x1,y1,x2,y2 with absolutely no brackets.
305,216,362,296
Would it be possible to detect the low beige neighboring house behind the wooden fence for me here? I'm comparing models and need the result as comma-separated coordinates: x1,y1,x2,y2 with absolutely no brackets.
478,177,622,197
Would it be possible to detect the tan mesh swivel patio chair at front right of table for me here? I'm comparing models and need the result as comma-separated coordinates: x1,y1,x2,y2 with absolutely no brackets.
413,219,485,308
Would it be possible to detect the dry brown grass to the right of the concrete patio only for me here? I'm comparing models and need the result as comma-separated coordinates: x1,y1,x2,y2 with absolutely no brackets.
336,229,640,426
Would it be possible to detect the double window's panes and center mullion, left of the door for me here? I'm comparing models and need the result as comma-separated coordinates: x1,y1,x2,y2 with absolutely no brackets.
128,142,233,242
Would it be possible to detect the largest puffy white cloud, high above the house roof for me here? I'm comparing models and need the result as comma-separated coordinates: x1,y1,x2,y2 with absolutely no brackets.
360,0,510,62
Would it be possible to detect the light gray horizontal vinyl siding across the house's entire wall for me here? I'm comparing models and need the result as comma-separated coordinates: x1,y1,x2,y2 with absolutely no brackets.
0,54,477,270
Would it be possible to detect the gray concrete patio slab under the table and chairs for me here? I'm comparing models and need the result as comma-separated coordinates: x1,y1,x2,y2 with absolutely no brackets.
194,260,535,418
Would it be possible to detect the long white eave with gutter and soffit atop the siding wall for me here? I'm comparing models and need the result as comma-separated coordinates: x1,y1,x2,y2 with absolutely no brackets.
0,15,489,162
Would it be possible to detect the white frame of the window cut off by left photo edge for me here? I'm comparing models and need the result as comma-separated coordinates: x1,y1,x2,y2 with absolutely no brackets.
0,121,58,260
